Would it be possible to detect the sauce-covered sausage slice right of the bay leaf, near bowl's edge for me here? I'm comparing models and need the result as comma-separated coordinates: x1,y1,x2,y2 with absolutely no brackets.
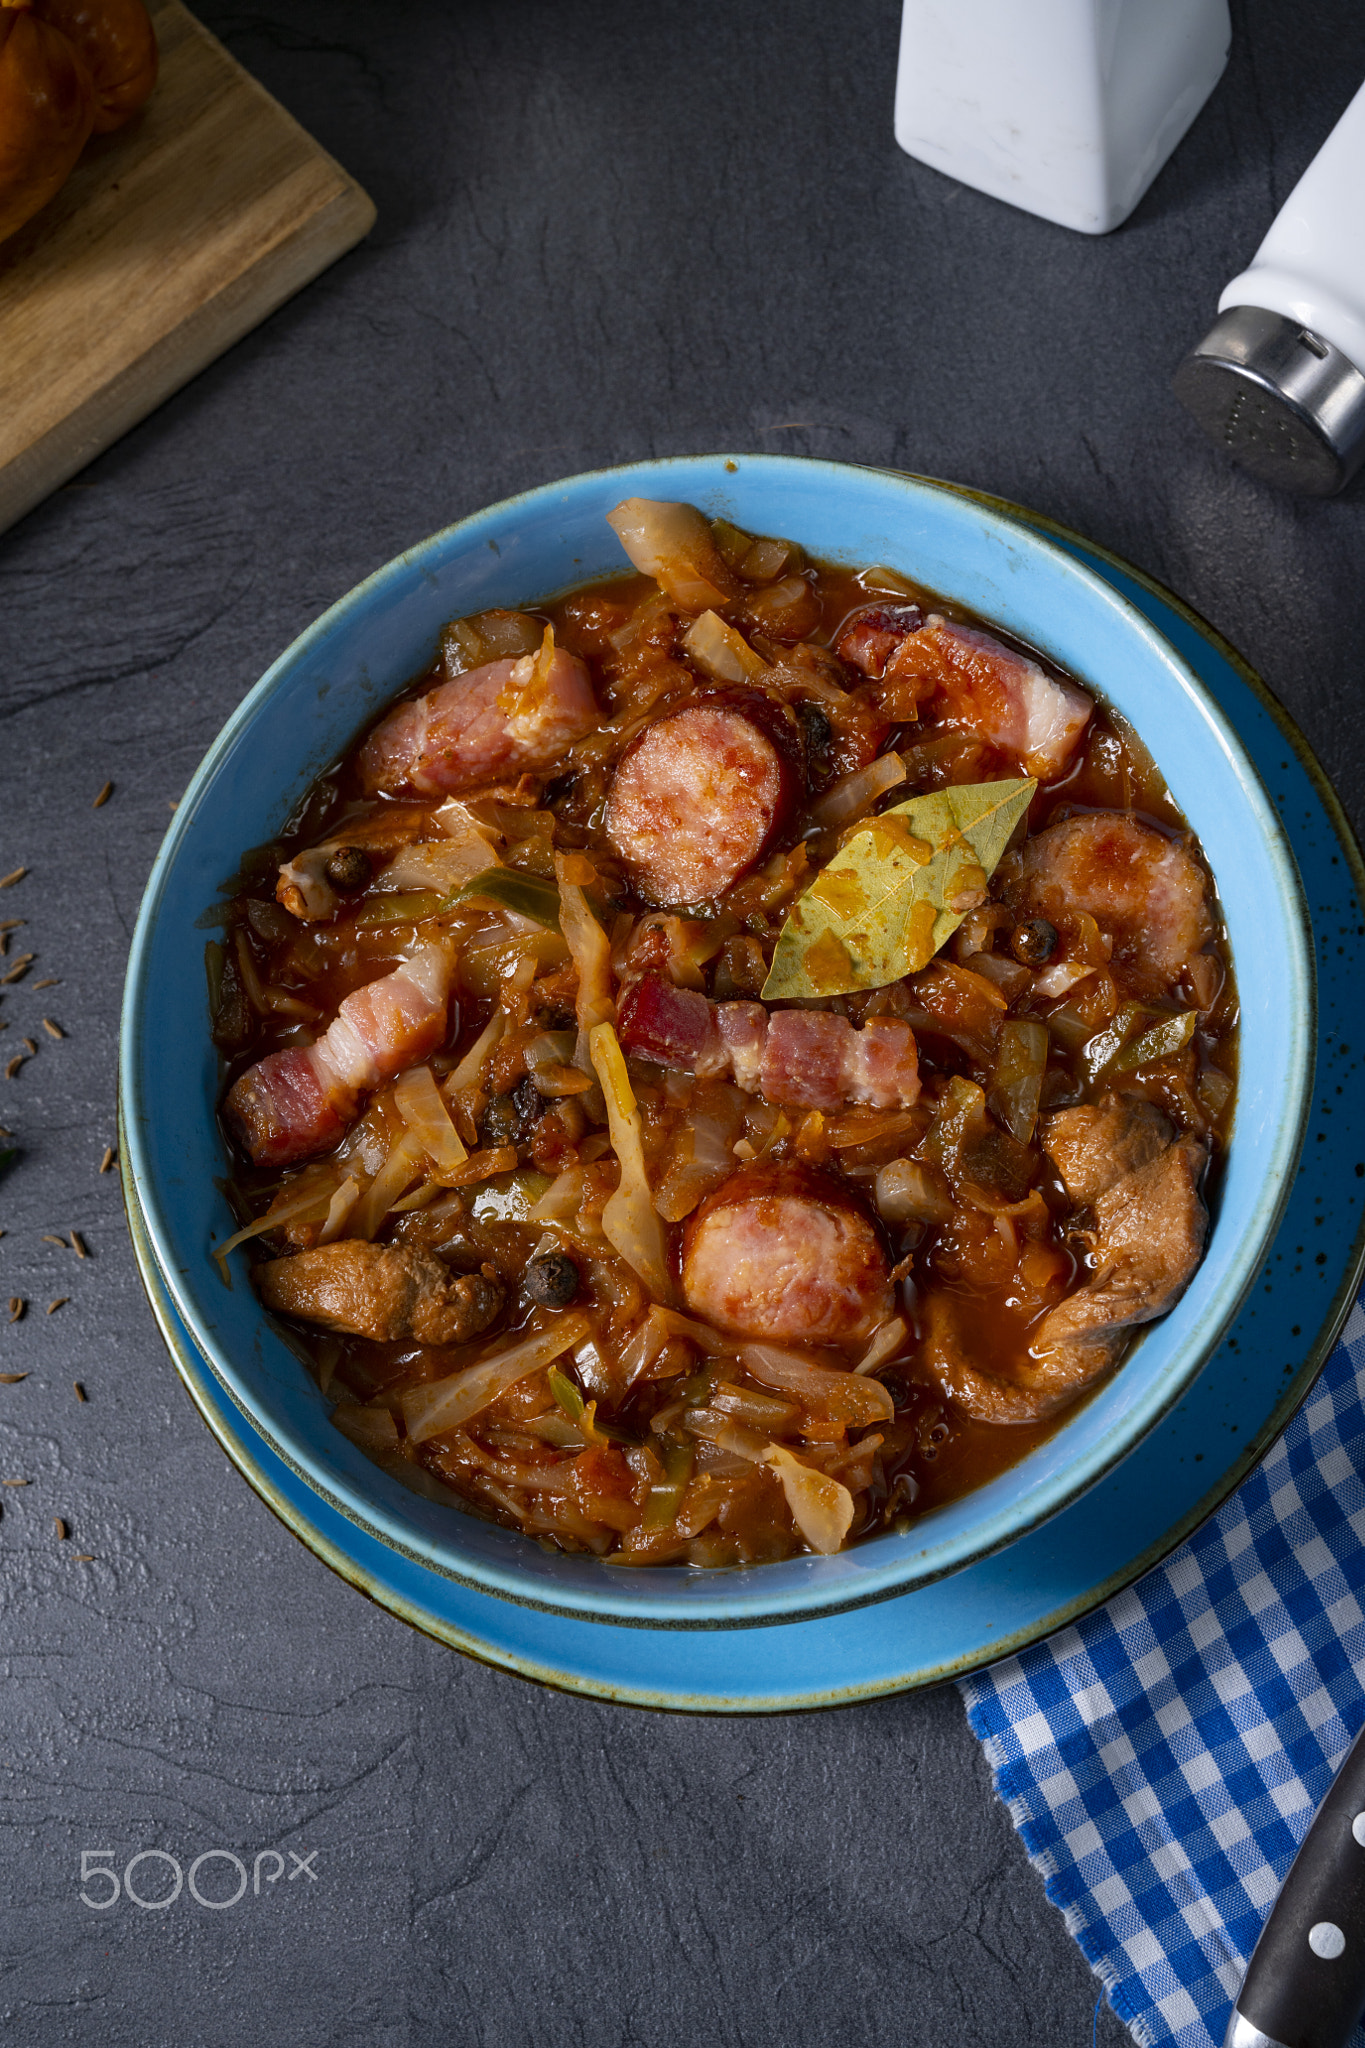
1001,811,1214,995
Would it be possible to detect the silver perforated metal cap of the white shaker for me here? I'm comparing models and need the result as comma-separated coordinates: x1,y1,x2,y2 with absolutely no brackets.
1173,305,1365,498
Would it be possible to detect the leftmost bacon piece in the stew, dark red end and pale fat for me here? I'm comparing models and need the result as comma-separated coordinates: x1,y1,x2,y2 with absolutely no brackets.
223,944,450,1165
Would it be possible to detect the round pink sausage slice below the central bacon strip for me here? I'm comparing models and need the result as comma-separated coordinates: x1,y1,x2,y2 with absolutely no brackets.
681,1165,894,1346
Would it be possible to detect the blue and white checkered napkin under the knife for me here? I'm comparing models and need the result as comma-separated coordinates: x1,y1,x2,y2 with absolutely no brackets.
962,1296,1365,2048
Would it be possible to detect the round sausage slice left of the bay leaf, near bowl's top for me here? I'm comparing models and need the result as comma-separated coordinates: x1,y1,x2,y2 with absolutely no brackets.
606,694,800,909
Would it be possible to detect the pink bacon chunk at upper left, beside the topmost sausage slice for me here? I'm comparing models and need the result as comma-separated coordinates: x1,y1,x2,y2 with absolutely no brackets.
360,647,600,797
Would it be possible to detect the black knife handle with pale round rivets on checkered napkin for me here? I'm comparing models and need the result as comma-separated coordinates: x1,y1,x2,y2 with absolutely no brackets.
1228,1729,1365,2048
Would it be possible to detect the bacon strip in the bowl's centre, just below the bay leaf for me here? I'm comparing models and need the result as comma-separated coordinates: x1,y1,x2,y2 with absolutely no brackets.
616,975,919,1110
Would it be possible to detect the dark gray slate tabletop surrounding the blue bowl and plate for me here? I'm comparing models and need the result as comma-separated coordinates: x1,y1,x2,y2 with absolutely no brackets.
0,0,1365,2048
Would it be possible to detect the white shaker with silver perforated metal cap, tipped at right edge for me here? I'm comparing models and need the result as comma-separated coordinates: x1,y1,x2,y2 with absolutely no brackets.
1175,73,1365,498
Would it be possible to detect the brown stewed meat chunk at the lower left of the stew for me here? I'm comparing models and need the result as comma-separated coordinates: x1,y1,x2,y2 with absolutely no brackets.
252,1237,503,1343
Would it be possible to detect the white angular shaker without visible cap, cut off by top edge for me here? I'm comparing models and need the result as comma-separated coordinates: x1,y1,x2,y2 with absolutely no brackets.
896,0,1232,236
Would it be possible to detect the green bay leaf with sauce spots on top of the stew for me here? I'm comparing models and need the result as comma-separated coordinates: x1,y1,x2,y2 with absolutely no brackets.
763,776,1038,1001
